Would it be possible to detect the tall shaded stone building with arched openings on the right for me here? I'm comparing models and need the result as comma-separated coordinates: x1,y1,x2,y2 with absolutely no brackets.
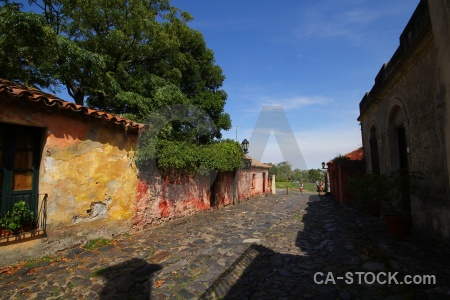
358,0,450,238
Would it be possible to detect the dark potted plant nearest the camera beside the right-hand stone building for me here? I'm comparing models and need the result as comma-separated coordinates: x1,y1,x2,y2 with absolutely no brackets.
382,171,421,237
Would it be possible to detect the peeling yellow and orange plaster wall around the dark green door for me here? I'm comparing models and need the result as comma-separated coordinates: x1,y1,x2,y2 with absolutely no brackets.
0,101,138,260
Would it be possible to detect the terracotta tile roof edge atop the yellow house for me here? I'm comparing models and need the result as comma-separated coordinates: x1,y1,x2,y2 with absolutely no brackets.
0,78,144,130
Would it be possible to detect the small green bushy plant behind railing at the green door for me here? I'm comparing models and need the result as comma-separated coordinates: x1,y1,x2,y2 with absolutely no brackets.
0,200,35,232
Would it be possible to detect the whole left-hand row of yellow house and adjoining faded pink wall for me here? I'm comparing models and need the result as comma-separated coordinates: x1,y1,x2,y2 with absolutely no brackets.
0,79,270,266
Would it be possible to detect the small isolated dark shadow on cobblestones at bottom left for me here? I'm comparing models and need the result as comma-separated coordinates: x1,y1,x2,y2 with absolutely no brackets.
95,258,162,300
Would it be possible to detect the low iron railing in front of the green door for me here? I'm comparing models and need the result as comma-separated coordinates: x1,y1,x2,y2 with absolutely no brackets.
0,194,48,242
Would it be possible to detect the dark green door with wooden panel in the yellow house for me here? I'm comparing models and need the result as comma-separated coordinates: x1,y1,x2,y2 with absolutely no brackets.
0,123,41,215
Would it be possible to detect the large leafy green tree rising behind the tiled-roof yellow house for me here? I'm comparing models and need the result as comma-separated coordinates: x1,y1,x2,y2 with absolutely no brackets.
0,0,238,172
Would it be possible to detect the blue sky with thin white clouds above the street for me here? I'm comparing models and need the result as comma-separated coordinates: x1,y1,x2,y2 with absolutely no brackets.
171,0,419,169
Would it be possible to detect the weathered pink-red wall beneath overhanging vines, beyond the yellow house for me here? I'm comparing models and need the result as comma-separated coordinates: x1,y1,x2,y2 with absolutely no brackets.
133,168,270,229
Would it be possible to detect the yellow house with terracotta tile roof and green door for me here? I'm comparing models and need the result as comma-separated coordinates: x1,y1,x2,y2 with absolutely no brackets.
0,79,142,265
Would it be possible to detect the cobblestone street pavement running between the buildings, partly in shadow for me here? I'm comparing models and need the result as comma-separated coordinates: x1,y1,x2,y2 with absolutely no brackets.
0,192,450,300
